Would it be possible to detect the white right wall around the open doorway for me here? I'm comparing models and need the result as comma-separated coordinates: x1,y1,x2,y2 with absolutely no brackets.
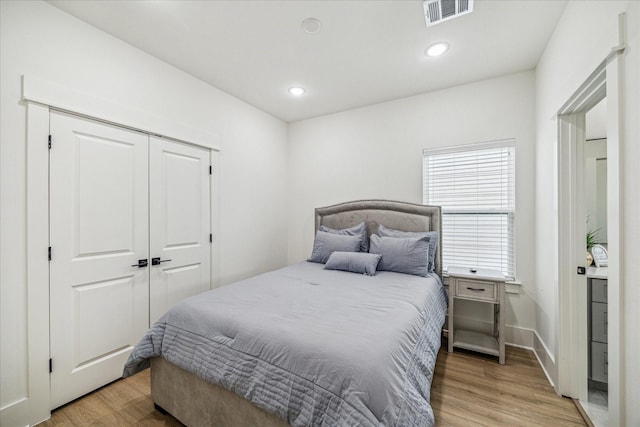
535,1,640,425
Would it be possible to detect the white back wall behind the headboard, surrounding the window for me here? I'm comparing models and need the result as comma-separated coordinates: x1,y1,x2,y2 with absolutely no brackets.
289,72,535,338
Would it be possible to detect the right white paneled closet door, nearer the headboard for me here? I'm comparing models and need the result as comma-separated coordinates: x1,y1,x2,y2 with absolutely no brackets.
149,137,211,323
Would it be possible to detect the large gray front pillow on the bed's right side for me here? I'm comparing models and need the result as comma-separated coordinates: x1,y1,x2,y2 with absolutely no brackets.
369,234,429,277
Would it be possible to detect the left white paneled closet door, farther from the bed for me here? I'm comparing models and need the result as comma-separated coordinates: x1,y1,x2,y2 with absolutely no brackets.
50,112,150,408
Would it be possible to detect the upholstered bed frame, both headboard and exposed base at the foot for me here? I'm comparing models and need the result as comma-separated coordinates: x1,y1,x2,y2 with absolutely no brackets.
151,200,442,427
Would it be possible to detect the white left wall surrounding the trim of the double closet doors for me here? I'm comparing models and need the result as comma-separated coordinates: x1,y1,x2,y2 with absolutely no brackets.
0,1,287,425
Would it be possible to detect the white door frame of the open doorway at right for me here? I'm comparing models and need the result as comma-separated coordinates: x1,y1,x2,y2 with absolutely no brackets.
556,44,624,425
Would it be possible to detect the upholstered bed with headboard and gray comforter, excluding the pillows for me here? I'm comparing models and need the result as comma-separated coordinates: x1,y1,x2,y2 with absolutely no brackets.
124,200,447,427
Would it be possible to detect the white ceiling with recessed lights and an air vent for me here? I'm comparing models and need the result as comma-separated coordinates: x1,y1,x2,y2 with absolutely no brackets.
50,0,566,122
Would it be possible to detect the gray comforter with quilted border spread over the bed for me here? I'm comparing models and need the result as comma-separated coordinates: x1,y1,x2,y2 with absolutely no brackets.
124,262,447,426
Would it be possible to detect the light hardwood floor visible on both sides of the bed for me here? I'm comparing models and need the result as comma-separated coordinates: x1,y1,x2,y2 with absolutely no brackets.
39,345,586,427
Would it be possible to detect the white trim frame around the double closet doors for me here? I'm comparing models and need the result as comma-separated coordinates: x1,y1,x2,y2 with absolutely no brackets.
23,76,220,425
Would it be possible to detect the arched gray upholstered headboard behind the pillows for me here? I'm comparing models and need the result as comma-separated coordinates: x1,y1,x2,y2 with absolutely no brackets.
316,200,442,277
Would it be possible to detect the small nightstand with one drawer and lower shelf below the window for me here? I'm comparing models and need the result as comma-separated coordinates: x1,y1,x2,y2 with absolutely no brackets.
448,267,507,365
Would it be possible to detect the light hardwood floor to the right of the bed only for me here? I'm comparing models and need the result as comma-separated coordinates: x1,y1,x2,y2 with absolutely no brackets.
431,346,586,427
